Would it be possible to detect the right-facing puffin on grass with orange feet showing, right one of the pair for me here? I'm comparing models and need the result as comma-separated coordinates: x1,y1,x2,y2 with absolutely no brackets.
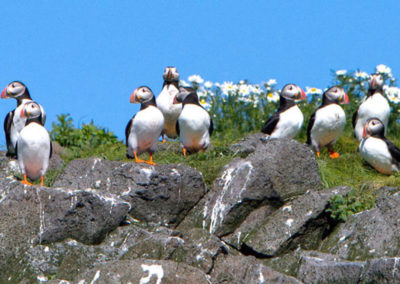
307,86,349,159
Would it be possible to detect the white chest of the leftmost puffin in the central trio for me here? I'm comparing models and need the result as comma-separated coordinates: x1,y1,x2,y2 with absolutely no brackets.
128,106,164,152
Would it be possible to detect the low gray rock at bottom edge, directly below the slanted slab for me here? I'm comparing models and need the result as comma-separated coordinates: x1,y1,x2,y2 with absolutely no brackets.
210,254,301,284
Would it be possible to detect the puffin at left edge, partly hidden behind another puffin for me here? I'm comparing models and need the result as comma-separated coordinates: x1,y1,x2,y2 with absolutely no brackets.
1,81,46,158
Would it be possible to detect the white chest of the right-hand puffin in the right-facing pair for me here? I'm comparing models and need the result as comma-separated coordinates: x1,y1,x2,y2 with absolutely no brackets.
311,104,346,147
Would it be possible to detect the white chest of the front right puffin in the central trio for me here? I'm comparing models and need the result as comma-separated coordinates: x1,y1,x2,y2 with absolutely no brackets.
179,104,210,149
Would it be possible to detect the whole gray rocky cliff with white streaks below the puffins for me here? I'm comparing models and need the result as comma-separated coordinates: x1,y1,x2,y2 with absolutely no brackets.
0,135,400,284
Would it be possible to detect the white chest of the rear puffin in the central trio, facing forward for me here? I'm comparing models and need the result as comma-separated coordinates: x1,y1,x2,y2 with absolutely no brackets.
156,84,182,138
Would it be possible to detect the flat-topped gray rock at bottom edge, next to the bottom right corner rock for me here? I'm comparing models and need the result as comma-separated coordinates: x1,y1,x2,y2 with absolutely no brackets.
297,252,365,284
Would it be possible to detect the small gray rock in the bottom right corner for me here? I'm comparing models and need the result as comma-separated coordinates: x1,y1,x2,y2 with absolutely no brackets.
359,257,400,283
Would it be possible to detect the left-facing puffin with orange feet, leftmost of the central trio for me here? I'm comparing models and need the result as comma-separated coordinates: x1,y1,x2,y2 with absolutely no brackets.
125,86,164,165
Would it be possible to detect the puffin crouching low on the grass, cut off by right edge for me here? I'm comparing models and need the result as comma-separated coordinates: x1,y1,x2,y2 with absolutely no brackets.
358,117,400,175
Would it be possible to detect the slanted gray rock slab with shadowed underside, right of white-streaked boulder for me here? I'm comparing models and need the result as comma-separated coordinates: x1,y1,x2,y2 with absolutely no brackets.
241,187,351,256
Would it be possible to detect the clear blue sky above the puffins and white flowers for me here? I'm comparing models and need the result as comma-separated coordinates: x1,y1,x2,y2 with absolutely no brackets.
0,0,400,145
